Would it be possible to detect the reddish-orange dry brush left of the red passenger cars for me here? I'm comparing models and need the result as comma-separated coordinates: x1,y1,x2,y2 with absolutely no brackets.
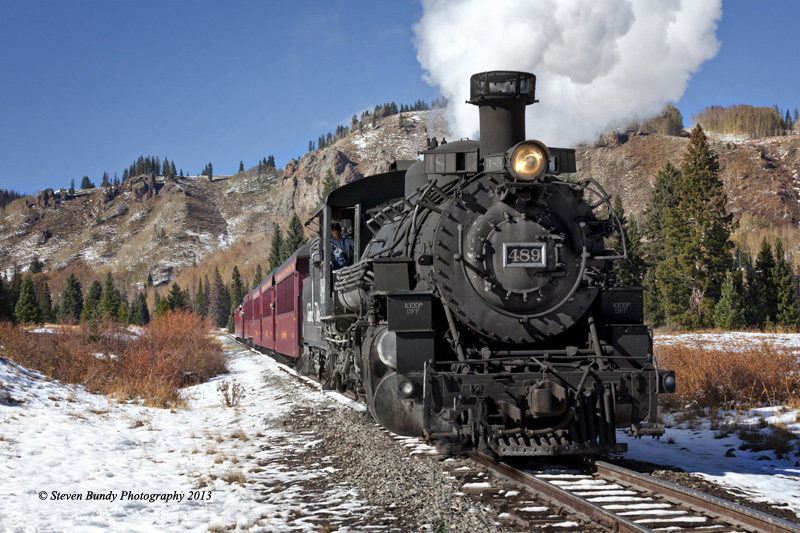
0,313,225,407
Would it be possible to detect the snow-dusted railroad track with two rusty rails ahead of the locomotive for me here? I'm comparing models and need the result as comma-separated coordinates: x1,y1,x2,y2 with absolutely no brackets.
469,453,800,533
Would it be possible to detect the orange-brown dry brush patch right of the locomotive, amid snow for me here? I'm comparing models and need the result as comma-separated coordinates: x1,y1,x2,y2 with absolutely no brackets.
655,342,800,408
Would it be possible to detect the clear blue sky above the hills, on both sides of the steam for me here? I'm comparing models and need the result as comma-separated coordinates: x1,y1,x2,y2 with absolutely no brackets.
0,0,800,193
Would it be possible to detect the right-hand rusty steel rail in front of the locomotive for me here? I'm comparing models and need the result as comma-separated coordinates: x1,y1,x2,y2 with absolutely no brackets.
590,461,800,533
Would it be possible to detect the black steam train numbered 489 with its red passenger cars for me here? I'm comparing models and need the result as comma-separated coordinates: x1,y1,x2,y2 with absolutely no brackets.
236,71,675,456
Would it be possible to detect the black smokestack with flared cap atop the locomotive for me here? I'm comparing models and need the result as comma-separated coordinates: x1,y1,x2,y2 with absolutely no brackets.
467,70,537,157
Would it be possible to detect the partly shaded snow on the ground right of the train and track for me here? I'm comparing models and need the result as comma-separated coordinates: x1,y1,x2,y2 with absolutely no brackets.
617,332,800,516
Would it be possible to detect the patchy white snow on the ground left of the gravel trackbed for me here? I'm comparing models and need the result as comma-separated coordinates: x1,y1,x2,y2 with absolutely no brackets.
0,338,364,532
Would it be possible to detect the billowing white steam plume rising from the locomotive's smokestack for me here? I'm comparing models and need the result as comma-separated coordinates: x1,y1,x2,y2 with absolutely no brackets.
414,0,722,147
